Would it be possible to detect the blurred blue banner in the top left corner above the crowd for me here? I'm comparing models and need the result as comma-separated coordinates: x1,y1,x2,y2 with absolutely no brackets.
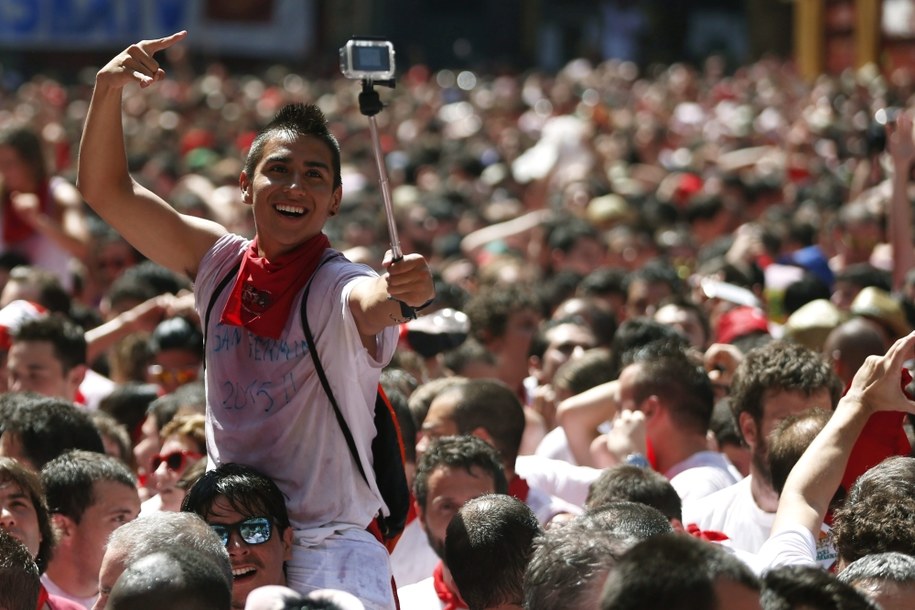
0,0,317,58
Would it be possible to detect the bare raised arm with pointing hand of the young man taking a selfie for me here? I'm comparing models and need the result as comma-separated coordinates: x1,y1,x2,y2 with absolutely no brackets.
77,32,225,278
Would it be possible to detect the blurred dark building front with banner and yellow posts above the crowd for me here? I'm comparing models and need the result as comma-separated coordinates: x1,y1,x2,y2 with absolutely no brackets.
0,0,915,81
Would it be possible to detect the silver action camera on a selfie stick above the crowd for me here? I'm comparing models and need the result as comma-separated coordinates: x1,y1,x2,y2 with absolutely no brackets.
340,38,416,320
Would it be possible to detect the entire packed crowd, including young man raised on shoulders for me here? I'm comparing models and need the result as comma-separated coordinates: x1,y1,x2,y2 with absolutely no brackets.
0,26,915,610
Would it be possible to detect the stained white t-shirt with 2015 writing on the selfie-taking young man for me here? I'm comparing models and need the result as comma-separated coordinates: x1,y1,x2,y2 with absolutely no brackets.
194,234,397,545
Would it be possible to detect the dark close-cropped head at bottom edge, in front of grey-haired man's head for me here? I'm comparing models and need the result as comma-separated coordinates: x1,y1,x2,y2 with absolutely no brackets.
105,549,232,610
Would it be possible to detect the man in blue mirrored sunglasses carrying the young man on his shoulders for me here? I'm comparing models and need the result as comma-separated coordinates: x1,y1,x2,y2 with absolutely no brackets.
181,464,292,610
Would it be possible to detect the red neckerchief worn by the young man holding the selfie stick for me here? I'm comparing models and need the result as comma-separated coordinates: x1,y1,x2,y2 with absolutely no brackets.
219,233,330,339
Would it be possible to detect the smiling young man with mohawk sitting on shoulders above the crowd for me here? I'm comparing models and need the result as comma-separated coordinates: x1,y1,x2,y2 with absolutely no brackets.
78,32,434,608
